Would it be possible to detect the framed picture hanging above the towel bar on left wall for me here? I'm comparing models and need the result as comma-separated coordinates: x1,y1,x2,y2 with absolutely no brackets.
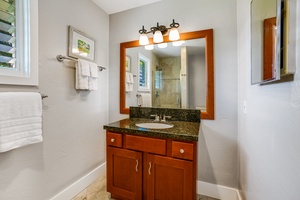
68,26,96,61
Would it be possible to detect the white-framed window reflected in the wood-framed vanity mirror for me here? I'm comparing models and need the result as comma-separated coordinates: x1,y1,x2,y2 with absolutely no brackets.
138,53,151,91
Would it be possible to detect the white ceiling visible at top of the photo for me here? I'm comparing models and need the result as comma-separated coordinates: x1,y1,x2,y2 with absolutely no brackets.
92,0,162,14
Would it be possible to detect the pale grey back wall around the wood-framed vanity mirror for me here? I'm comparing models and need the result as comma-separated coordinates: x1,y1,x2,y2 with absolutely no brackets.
109,0,237,188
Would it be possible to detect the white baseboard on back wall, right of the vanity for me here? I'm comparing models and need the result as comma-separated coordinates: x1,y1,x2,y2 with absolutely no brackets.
197,181,242,200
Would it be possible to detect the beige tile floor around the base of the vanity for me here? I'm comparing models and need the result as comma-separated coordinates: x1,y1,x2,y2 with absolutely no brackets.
72,176,218,200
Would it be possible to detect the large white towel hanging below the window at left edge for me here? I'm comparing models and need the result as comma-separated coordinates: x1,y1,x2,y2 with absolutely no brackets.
0,92,43,152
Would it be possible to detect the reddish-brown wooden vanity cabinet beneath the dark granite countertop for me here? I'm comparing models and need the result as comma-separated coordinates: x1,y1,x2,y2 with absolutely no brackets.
107,131,197,200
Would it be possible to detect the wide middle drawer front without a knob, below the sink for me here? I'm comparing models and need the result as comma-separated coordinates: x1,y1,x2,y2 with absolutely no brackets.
125,135,166,155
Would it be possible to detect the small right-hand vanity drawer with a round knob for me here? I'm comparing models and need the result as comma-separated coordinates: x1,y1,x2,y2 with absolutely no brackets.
172,141,194,160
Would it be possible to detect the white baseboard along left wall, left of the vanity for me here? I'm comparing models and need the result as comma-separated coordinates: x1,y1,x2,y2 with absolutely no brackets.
50,163,106,200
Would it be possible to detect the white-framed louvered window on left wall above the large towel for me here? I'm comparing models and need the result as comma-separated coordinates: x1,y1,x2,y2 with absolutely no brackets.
0,0,38,85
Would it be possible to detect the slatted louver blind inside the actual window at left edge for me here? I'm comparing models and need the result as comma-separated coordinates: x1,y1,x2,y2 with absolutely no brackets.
0,0,16,68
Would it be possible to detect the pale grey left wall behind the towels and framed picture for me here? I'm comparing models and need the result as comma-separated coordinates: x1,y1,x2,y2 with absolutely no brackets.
0,0,109,200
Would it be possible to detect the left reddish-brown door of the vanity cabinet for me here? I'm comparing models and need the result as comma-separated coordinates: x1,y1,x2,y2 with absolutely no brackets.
107,147,143,200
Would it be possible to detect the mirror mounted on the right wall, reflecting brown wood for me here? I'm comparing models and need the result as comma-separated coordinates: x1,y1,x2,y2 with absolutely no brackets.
251,0,285,85
